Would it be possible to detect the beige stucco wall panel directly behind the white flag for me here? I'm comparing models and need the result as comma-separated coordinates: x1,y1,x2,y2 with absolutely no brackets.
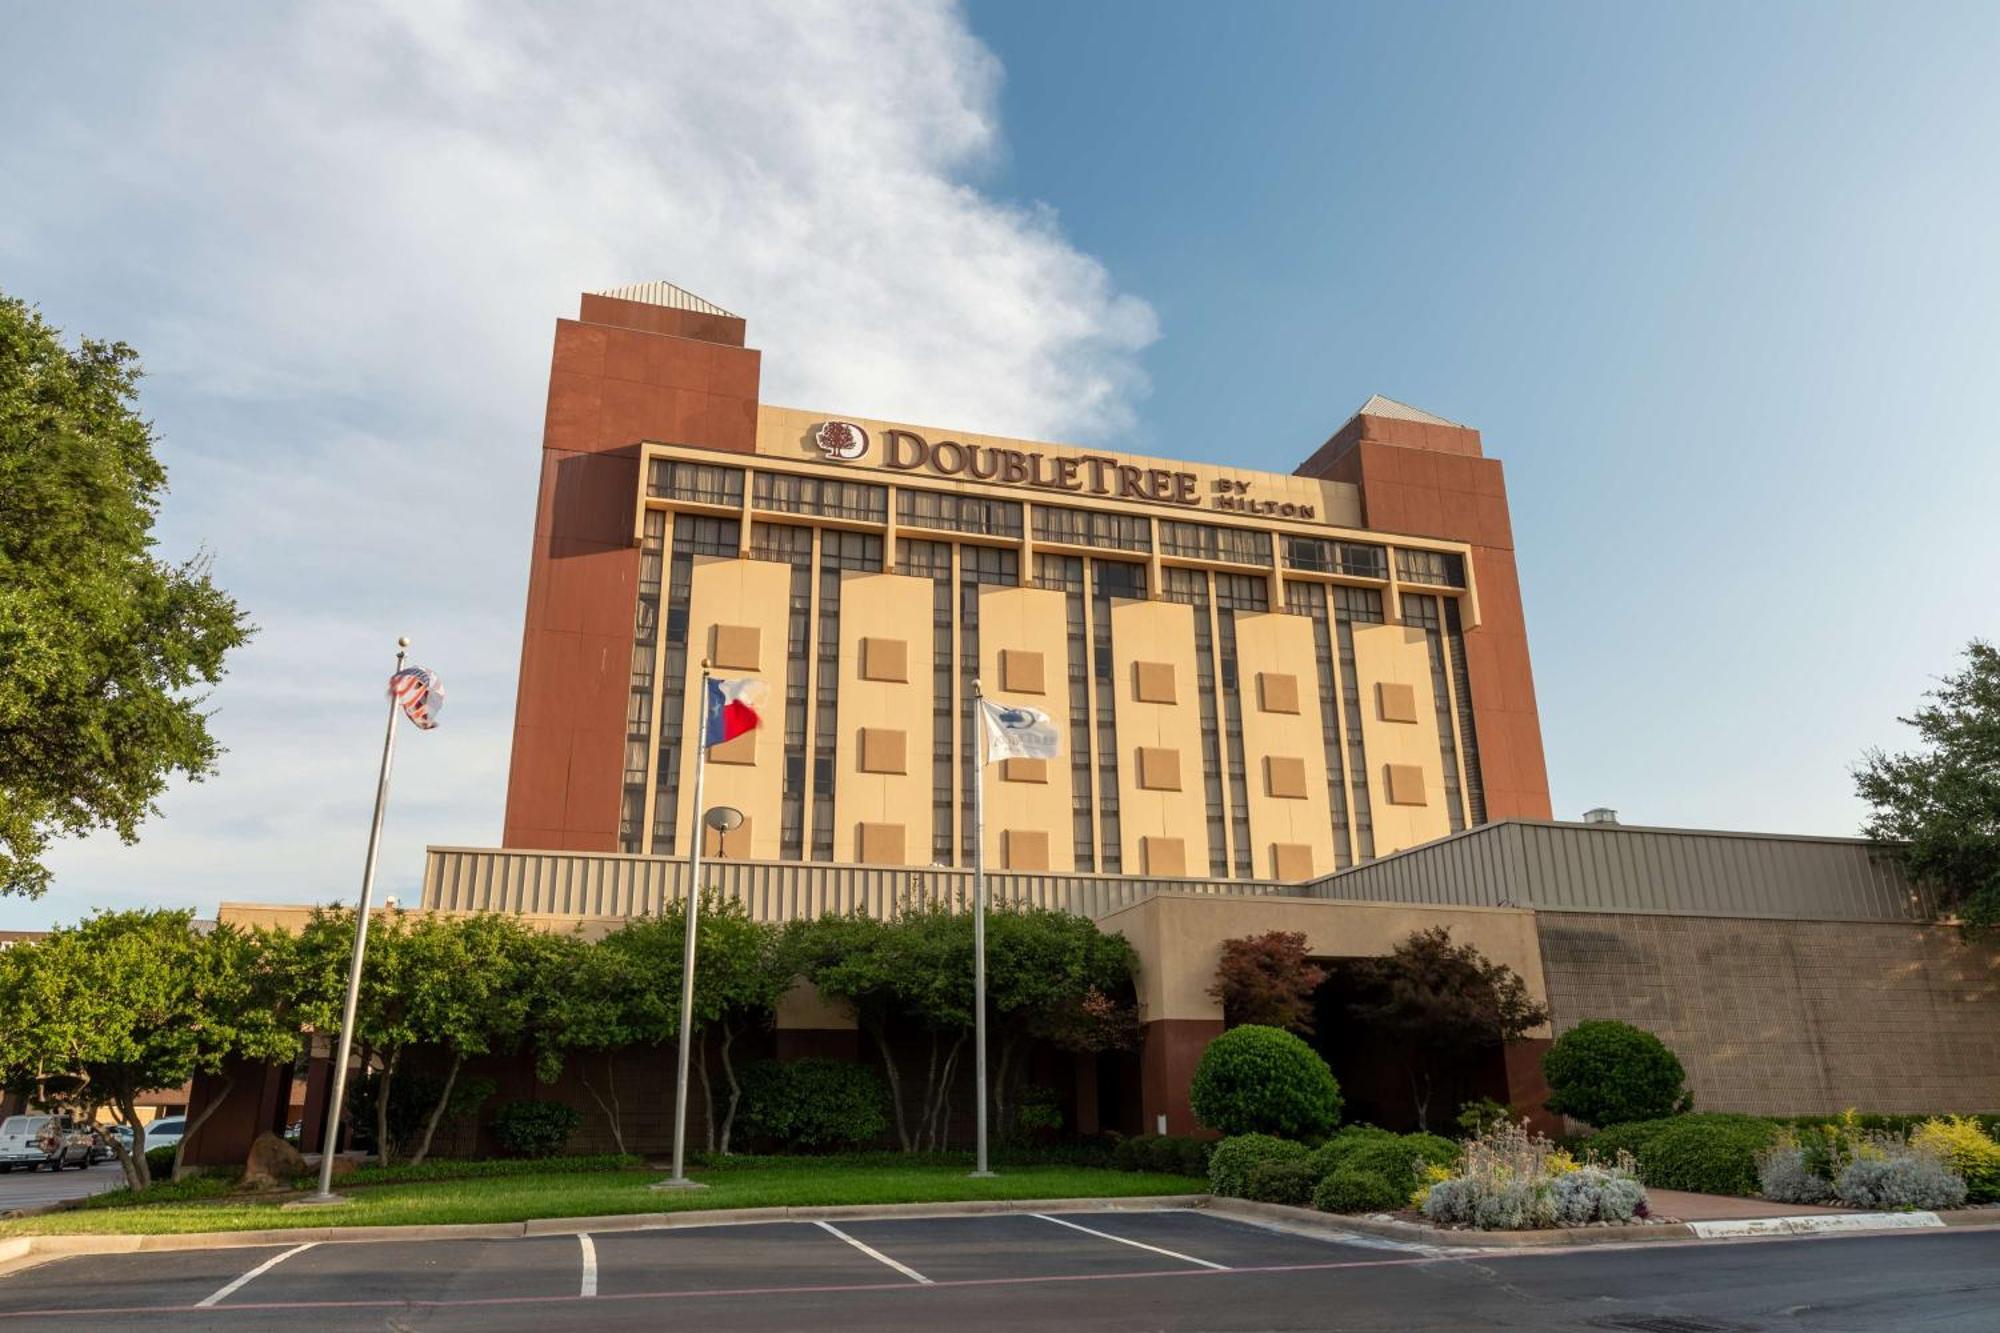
972,582,1076,871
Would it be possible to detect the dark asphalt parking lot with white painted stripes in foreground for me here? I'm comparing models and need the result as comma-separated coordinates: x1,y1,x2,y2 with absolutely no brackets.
0,1211,2000,1333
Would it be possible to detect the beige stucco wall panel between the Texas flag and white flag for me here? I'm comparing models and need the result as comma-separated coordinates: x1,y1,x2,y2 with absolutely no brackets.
834,570,936,865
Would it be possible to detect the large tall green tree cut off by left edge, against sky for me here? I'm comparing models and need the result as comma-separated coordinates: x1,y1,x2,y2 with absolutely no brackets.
0,294,250,897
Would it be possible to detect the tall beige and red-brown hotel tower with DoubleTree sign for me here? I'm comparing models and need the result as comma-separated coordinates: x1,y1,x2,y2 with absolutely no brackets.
504,282,1550,883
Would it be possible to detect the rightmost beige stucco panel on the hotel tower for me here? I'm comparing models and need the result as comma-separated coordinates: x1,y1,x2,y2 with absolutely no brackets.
1354,624,1452,844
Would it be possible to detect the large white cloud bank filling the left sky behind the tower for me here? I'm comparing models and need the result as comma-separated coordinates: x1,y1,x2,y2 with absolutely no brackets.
0,0,1154,925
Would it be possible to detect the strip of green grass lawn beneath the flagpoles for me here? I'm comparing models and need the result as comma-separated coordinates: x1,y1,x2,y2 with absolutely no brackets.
0,1157,1208,1237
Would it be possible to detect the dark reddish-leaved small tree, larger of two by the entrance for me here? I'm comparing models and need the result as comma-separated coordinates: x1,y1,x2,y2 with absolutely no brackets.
1350,927,1548,1131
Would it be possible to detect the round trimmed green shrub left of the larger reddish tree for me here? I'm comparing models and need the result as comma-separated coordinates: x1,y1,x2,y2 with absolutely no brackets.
1188,1025,1340,1139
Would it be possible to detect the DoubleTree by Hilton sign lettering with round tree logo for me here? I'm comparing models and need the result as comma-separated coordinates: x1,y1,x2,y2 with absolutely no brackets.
812,420,1316,518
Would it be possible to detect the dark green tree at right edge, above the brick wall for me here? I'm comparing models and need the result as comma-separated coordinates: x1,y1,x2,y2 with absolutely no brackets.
1854,638,2000,933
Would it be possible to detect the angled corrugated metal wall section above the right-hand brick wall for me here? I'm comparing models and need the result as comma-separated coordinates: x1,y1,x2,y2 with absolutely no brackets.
1308,821,1932,921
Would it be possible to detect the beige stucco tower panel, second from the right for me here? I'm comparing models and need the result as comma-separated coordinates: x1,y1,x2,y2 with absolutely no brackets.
1236,612,1334,879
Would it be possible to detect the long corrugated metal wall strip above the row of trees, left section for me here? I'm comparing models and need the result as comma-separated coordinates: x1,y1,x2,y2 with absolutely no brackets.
424,847,1304,921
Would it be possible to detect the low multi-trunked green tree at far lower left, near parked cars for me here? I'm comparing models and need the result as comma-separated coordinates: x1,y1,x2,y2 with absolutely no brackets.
0,911,298,1189
